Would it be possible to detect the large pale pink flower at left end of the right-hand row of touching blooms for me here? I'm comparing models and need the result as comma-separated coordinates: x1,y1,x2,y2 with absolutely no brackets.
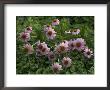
55,42,68,54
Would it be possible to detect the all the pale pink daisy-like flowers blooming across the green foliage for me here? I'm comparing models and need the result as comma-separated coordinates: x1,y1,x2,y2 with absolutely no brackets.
20,19,93,73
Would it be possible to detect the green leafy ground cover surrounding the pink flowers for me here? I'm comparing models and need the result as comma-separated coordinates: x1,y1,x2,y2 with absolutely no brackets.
16,16,94,74
